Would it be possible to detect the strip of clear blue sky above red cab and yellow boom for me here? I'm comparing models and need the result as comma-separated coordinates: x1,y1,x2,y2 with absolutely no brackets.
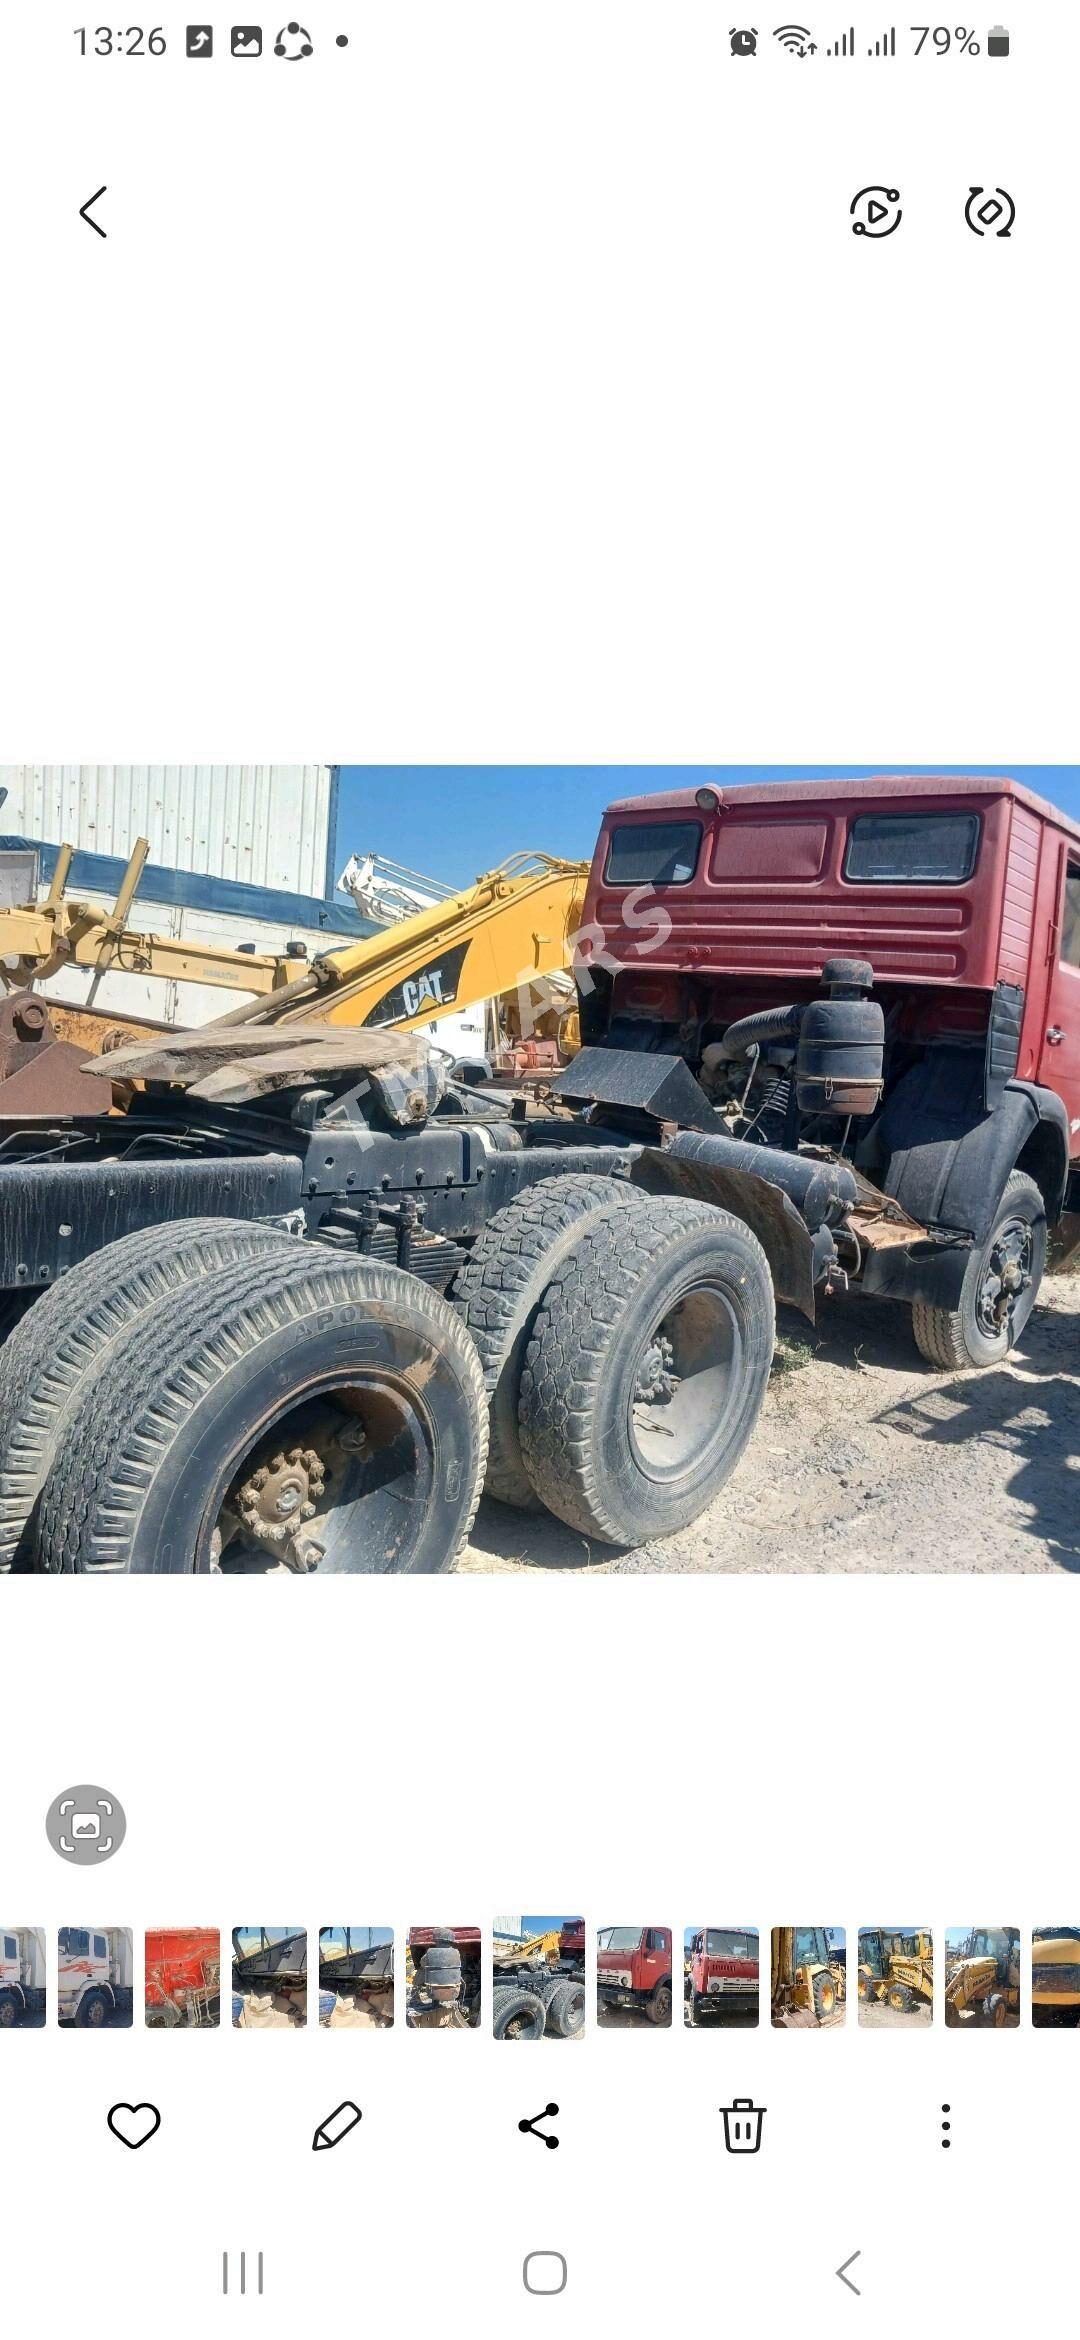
337,758,1080,887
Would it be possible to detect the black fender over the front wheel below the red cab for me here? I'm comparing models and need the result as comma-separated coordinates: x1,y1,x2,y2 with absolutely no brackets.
879,1048,1068,1243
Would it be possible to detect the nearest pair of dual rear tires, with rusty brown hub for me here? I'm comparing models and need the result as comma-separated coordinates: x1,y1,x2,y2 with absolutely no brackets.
0,1221,486,1575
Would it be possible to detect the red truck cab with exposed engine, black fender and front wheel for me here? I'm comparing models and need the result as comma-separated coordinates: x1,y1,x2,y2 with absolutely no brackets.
565,775,1080,1367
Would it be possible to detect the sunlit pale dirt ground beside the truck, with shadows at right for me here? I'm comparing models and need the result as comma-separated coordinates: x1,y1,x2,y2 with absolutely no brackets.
458,1275,1080,1575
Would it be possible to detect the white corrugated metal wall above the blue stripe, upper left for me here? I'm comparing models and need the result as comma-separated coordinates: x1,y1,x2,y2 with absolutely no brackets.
0,763,337,896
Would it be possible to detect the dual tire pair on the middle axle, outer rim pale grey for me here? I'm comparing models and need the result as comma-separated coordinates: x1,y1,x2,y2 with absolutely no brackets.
454,1177,776,1547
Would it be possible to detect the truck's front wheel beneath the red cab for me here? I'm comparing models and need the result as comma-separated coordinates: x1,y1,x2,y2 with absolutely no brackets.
912,1170,1047,1374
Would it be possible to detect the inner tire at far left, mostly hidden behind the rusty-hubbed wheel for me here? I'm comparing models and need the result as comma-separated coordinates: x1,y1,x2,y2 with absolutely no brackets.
0,1219,295,1568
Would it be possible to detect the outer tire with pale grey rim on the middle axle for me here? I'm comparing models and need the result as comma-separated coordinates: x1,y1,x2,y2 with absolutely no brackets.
519,1196,776,1544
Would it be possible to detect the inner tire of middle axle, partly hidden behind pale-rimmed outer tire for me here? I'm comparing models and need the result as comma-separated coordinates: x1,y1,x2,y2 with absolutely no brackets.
451,1172,634,1512
